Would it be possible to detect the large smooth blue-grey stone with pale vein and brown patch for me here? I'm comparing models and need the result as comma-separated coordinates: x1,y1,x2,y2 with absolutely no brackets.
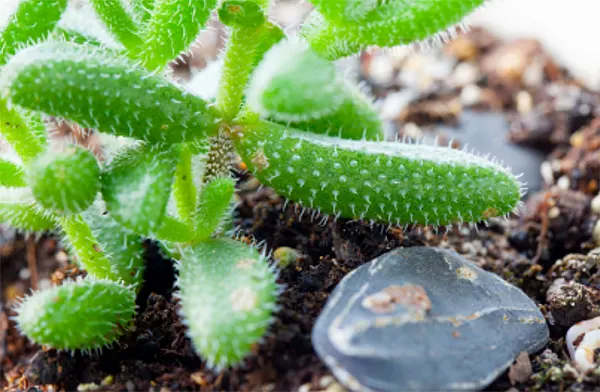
312,247,548,391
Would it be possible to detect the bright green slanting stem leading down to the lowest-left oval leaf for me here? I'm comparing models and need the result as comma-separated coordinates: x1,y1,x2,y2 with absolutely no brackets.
59,215,120,281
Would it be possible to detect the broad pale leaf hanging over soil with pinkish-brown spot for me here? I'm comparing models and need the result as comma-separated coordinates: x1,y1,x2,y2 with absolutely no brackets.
178,239,278,368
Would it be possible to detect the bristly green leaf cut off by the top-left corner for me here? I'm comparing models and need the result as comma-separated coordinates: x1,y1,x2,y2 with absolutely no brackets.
0,0,67,65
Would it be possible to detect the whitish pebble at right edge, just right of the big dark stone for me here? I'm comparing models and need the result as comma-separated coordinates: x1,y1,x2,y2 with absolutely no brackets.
566,317,600,372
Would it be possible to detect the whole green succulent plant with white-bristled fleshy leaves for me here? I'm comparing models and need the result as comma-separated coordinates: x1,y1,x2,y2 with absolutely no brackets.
0,0,521,367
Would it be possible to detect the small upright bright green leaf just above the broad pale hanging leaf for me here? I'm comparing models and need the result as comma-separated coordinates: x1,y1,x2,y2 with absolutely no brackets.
195,177,235,240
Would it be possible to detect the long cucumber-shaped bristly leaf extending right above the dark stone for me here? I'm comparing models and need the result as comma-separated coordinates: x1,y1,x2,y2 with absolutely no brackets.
233,122,521,226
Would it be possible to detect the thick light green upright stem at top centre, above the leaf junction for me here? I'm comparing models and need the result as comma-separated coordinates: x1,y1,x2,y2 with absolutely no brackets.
217,23,284,120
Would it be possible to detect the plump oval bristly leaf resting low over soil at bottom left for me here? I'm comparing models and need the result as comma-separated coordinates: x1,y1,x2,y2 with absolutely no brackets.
15,278,135,350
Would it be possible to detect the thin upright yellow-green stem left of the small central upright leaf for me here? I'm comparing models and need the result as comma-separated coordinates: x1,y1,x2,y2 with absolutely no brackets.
173,145,196,224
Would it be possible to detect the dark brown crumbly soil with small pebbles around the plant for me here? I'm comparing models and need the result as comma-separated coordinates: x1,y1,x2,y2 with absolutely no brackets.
0,26,600,392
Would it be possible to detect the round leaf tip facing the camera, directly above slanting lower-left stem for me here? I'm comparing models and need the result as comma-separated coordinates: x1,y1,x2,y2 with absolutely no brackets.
27,145,100,214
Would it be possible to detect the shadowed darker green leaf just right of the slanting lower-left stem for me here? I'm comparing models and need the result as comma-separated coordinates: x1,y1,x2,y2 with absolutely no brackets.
82,200,145,290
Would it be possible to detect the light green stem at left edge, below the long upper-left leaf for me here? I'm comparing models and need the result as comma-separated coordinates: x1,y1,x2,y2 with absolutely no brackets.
0,98,47,164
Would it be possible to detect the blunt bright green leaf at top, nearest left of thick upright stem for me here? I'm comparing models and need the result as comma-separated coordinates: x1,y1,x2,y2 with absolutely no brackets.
139,0,217,70
